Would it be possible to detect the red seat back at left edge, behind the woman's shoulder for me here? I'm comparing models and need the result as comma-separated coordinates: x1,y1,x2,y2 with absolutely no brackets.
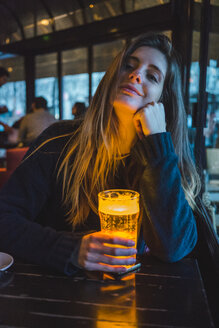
0,147,29,188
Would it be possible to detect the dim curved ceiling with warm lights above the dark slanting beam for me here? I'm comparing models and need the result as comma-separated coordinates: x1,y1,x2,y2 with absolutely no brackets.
0,0,169,45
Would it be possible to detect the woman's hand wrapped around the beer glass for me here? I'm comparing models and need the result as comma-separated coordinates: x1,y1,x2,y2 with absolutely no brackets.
78,231,137,272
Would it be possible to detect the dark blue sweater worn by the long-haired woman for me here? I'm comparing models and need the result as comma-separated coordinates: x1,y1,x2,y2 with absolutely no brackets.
0,121,197,274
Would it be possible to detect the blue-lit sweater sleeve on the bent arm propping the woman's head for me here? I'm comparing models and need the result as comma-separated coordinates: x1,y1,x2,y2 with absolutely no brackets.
132,132,197,262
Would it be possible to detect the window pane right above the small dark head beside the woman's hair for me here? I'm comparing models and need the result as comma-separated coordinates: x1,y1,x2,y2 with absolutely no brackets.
62,48,89,119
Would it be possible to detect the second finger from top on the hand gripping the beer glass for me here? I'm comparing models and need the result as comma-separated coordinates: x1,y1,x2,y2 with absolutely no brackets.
89,243,137,256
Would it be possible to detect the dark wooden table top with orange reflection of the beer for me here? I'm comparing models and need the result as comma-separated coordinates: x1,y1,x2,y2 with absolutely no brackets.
0,257,214,328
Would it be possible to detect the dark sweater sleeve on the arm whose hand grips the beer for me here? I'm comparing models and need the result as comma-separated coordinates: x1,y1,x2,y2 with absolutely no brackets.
0,121,82,274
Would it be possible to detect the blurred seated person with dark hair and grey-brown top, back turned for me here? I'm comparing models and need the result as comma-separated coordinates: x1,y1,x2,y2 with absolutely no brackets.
18,97,56,147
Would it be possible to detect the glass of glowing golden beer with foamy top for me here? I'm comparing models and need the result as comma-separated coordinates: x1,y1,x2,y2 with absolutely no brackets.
98,189,139,267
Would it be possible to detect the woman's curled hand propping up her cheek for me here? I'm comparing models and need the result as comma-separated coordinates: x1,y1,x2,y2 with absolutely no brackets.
133,102,166,139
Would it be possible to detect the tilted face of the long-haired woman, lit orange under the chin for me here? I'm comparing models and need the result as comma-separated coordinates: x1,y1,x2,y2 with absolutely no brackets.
114,46,167,115
